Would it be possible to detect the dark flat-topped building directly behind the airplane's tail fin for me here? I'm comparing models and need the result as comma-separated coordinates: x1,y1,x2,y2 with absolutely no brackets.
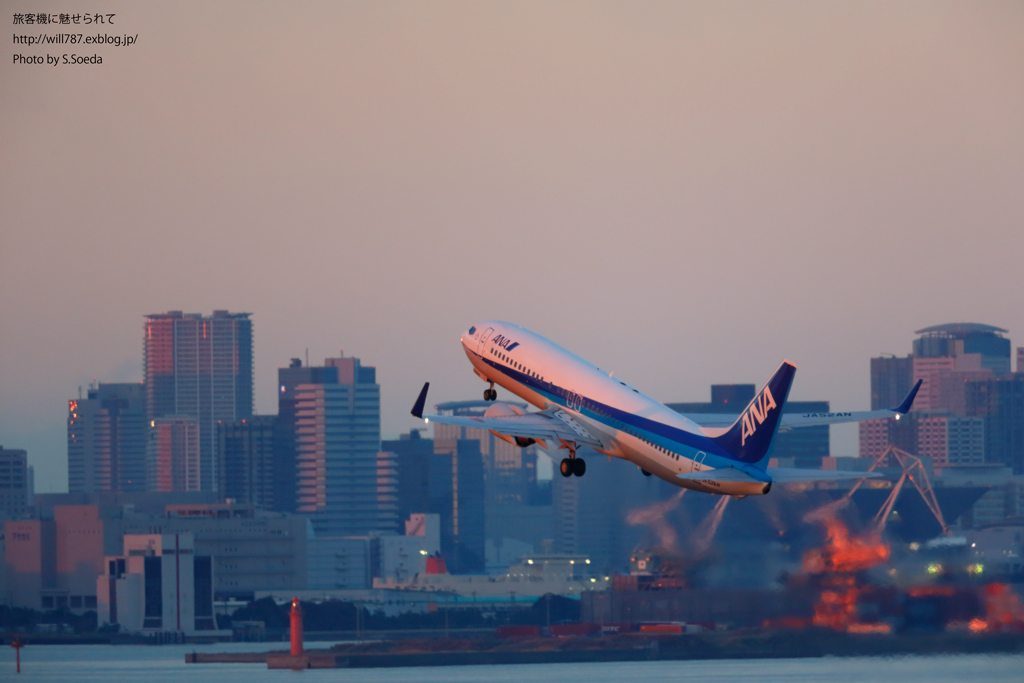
666,384,827,468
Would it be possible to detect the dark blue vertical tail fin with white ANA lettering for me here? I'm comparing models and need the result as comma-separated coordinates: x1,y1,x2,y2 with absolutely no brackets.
715,360,797,469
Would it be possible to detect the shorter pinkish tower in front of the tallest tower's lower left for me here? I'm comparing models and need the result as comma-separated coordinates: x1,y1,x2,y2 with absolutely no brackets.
146,418,203,492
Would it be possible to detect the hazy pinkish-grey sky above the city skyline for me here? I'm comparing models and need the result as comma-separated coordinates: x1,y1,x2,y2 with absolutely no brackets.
0,2,1024,492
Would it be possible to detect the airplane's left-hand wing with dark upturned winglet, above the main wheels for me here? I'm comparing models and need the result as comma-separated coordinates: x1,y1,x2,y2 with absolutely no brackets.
413,382,603,449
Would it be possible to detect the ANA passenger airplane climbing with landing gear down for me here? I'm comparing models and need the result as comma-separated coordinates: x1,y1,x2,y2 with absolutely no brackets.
412,321,921,498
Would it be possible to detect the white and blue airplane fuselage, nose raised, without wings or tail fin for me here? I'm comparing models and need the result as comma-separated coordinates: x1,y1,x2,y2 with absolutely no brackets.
461,321,769,496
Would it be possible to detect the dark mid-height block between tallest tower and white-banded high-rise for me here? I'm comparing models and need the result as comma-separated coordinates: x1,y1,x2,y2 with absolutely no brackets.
217,415,278,510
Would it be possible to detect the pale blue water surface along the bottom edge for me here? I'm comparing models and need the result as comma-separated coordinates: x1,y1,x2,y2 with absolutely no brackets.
0,643,1024,683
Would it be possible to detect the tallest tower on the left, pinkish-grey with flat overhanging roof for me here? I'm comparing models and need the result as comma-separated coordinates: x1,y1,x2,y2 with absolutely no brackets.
143,310,253,490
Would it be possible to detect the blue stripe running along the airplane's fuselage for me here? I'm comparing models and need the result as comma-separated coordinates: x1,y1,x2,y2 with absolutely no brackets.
471,351,737,466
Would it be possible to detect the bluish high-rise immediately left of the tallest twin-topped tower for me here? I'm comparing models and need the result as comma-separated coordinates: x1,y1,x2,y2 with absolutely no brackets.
68,383,148,493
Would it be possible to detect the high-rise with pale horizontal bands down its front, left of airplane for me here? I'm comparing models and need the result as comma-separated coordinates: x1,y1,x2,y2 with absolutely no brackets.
274,357,385,536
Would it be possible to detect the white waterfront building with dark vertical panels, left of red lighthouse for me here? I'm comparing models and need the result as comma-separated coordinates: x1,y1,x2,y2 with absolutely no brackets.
96,533,217,636
